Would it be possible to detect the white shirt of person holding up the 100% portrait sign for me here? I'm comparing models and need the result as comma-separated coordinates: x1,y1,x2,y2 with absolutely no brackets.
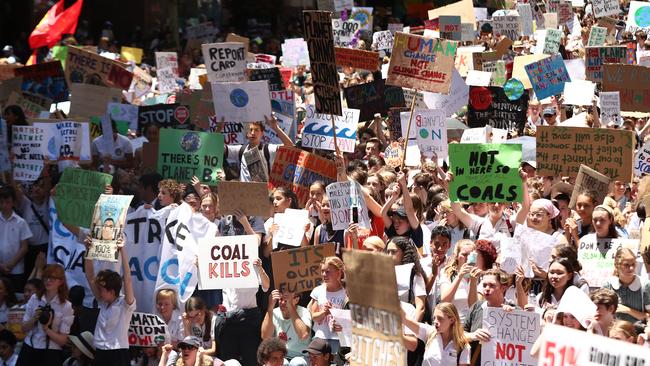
93,296,136,351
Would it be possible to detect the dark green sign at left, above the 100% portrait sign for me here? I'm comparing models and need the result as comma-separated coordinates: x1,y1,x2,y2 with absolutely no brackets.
54,168,113,228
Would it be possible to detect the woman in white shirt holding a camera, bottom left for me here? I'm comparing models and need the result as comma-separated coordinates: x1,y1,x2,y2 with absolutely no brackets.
16,264,74,366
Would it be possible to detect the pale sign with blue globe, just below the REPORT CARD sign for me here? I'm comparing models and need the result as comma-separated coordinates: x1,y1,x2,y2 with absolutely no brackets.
212,80,271,122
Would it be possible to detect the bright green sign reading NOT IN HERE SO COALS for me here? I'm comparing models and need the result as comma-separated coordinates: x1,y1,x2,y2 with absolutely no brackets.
449,144,522,202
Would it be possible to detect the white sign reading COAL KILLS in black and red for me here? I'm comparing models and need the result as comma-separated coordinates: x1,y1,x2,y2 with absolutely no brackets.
198,235,259,290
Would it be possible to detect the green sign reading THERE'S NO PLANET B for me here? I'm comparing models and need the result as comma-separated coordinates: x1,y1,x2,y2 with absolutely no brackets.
158,128,224,184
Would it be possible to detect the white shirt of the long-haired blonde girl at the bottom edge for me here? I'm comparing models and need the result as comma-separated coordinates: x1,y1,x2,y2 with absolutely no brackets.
417,323,470,366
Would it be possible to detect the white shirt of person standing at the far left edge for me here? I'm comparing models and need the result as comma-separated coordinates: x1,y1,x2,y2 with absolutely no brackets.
0,212,32,274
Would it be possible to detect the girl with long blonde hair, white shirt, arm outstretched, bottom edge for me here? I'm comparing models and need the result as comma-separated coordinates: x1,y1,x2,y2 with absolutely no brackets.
402,302,470,366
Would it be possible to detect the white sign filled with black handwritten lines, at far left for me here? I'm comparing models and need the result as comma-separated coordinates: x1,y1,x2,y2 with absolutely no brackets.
11,126,45,182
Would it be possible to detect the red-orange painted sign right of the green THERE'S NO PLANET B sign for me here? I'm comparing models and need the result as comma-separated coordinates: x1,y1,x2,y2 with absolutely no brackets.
269,146,336,204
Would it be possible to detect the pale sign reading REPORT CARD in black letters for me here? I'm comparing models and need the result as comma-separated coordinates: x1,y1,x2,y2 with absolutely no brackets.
201,42,246,83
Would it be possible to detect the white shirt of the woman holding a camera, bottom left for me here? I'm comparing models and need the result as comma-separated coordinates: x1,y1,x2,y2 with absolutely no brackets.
23,294,73,350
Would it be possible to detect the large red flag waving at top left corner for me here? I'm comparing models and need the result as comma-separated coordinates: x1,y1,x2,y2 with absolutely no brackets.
29,0,83,49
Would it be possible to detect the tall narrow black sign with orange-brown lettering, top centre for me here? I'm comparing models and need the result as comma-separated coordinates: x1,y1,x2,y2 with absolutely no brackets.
303,11,342,116
